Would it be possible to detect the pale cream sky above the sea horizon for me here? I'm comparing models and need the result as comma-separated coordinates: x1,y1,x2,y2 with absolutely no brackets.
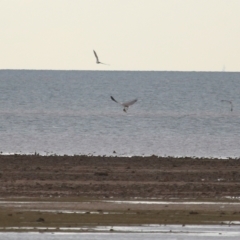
0,0,240,72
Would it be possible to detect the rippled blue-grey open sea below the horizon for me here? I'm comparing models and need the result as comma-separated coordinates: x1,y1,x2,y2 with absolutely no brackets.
0,70,240,158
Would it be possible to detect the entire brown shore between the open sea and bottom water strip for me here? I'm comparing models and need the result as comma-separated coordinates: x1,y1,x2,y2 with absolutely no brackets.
0,155,240,230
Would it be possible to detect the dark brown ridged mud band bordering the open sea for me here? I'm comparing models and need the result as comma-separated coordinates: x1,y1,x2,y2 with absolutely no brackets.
0,155,240,198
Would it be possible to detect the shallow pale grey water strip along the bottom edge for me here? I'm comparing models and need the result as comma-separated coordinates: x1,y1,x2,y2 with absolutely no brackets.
0,225,240,240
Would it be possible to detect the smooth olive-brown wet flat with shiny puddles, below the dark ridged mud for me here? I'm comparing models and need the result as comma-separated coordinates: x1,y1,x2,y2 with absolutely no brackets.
0,197,240,232
